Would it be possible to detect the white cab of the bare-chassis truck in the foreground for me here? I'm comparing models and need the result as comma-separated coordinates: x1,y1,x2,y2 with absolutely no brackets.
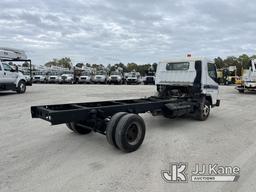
156,57,220,118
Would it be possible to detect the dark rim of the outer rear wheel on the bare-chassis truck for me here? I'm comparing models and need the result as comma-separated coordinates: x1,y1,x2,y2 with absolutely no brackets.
126,123,142,145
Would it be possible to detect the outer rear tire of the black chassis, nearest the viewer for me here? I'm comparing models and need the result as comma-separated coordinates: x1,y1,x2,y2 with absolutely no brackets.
115,114,146,153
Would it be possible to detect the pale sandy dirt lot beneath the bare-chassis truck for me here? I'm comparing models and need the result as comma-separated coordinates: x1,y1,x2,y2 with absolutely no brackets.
0,85,256,192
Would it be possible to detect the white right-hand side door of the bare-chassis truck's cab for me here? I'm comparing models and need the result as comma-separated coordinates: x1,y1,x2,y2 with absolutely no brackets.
203,62,219,104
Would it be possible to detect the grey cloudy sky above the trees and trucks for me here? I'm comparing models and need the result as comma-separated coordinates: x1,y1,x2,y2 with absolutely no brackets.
0,0,256,64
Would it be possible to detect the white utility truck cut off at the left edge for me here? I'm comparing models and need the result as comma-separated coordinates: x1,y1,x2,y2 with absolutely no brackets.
0,48,32,93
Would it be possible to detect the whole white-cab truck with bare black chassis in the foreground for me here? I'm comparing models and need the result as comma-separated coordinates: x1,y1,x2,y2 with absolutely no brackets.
31,57,220,152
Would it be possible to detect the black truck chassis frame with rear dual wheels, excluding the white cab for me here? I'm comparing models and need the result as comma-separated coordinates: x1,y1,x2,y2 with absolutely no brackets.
31,96,205,152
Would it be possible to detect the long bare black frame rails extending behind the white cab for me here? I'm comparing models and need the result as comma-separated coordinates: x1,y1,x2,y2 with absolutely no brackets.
31,97,184,125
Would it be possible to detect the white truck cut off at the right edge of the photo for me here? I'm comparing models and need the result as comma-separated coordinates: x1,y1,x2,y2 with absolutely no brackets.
236,59,256,93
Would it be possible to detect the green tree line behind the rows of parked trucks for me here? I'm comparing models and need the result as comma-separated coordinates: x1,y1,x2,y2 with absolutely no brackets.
45,54,256,75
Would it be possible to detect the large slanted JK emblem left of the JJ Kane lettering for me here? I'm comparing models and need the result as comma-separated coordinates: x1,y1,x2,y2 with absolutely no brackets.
161,163,188,183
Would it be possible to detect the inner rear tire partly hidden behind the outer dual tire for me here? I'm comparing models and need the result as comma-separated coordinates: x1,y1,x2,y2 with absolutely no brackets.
106,112,127,148
